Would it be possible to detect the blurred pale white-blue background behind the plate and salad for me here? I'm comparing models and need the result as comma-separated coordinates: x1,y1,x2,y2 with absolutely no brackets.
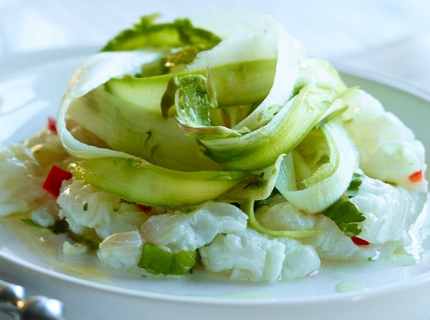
0,0,430,91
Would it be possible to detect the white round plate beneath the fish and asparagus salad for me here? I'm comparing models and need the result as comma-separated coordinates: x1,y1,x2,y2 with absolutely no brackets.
0,48,430,320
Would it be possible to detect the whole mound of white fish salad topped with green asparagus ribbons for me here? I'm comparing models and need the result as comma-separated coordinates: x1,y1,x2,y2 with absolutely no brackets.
0,9,427,282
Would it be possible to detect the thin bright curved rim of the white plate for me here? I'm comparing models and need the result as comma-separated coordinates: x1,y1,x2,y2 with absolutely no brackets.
0,46,430,306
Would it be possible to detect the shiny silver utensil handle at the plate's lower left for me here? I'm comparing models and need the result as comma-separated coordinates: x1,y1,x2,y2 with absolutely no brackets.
0,280,65,320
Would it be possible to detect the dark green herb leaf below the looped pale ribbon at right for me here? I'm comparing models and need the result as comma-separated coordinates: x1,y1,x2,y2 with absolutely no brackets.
321,198,366,237
